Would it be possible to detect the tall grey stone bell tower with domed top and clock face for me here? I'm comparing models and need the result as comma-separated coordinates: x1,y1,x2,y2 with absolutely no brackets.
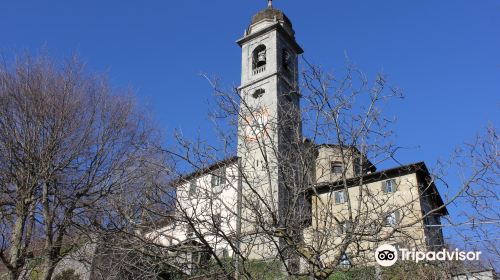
237,1,303,238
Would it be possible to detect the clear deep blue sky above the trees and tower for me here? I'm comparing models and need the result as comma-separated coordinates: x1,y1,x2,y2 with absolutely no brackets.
0,0,500,255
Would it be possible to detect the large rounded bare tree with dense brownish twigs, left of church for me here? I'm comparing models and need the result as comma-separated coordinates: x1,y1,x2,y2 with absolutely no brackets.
0,55,161,280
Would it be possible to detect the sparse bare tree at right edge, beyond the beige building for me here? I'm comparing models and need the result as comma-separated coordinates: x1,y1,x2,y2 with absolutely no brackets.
436,124,500,269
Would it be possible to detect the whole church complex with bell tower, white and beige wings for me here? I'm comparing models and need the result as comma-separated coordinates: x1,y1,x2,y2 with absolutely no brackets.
147,1,448,273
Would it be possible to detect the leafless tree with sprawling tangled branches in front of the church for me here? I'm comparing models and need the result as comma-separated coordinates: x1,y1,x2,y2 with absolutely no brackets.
128,62,497,279
